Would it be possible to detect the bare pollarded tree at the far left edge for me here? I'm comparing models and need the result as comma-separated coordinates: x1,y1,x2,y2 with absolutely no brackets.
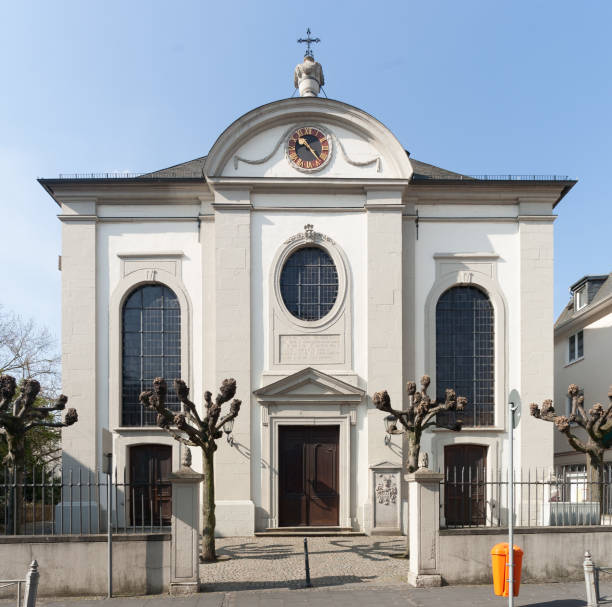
0,375,78,533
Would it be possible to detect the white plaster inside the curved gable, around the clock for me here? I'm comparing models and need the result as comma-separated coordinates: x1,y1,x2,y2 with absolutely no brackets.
222,123,391,179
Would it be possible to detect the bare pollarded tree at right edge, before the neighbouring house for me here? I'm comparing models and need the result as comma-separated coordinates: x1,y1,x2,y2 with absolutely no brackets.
530,384,612,503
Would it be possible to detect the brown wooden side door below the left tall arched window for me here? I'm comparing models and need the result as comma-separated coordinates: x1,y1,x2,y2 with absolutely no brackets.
126,445,172,527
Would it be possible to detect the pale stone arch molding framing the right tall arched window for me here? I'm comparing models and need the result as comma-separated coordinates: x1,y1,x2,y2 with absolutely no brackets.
424,263,509,431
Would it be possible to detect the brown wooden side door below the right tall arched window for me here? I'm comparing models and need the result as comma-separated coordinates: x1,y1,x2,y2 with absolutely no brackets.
444,445,487,526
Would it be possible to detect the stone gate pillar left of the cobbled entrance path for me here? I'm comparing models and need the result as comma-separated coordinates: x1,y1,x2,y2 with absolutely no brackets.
170,449,204,595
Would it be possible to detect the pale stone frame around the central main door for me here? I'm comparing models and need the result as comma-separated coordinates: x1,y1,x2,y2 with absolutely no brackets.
262,416,352,529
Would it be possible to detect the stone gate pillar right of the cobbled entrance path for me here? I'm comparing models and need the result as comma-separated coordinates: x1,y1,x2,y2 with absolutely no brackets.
405,468,444,588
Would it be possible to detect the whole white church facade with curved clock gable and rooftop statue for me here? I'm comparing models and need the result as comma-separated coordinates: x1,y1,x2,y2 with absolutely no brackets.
41,57,574,535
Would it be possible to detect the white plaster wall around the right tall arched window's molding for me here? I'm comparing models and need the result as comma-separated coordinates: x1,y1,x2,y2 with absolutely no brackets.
406,218,521,476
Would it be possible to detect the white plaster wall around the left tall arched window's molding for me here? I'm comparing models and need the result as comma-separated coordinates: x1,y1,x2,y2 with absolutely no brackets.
97,221,204,468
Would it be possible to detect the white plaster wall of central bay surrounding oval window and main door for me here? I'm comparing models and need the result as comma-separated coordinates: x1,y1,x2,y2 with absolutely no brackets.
251,209,368,515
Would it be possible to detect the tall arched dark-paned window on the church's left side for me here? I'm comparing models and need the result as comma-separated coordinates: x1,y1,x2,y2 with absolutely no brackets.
121,284,181,426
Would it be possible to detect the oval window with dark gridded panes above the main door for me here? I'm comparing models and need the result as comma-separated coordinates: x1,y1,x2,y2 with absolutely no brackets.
280,247,338,320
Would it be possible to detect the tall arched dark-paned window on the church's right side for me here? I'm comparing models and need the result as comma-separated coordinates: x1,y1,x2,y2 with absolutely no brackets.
436,286,495,426
